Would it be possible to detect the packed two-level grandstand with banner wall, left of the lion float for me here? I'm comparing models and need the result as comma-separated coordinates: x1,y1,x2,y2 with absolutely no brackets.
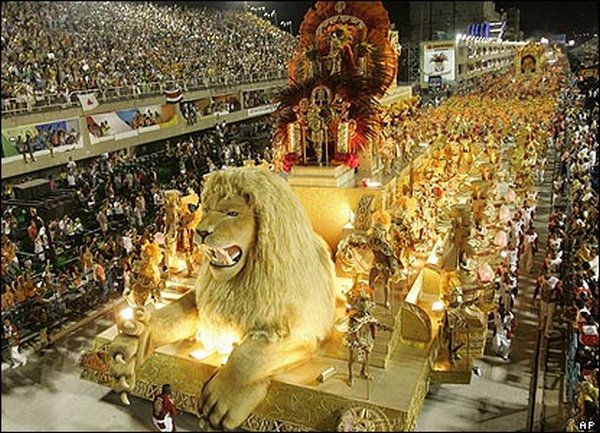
1,2,296,372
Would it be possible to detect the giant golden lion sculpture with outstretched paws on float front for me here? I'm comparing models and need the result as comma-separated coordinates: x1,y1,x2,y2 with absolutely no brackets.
110,168,335,429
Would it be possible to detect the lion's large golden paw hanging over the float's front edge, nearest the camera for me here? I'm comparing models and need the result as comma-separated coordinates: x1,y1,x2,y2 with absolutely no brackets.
198,371,269,430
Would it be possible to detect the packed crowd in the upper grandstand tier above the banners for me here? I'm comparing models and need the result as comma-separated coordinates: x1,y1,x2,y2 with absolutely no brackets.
1,1,296,108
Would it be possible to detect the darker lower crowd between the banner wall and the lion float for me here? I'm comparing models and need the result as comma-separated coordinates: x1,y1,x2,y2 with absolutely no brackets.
2,119,271,365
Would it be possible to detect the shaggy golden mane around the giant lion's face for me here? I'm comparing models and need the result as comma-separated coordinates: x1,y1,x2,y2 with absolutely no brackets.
196,168,335,339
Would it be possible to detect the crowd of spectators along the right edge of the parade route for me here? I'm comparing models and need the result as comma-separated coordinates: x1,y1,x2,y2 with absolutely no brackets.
547,74,600,431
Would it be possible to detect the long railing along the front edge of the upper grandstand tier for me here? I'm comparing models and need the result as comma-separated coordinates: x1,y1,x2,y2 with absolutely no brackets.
1,70,287,117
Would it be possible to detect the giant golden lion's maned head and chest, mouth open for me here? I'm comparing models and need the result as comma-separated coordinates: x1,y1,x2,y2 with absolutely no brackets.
196,168,335,338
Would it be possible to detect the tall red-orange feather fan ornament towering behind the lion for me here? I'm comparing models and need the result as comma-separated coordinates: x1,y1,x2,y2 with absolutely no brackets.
275,1,397,167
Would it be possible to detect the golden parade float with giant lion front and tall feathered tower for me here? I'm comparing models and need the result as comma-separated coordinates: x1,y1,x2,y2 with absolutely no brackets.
82,2,564,431
